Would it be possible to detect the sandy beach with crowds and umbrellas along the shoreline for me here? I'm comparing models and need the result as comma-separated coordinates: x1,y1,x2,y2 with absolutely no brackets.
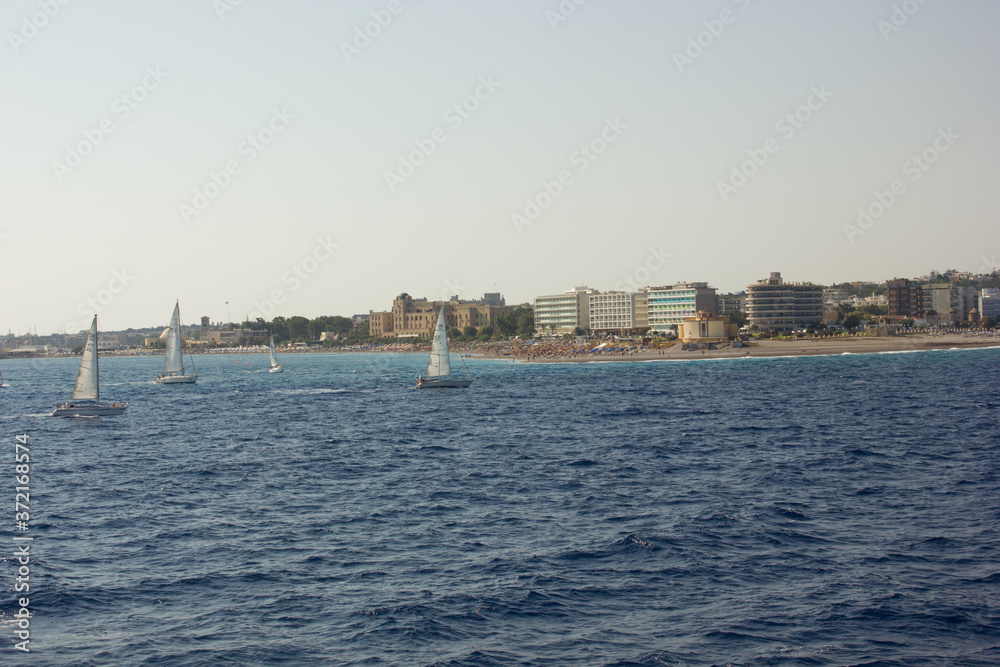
483,333,1000,363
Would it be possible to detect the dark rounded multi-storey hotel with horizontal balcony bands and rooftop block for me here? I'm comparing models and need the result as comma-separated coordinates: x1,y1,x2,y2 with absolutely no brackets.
747,272,823,331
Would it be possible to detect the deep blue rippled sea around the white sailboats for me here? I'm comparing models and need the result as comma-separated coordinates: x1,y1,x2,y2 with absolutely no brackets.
0,349,1000,667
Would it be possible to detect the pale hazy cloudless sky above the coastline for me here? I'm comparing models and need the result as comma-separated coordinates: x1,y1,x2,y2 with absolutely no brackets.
0,0,1000,334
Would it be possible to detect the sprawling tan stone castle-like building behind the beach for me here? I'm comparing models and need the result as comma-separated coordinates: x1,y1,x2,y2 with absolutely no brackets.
368,292,514,338
